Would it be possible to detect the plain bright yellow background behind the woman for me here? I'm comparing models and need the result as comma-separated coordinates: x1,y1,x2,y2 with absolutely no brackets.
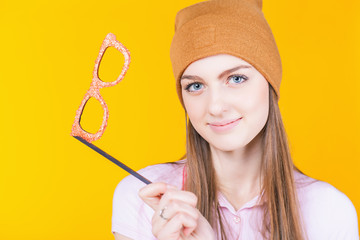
0,0,360,240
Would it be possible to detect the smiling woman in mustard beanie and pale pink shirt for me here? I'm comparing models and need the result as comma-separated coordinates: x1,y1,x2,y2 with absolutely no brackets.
112,0,359,240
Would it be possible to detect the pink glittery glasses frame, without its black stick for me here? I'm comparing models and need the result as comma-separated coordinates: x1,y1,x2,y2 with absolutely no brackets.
71,33,130,142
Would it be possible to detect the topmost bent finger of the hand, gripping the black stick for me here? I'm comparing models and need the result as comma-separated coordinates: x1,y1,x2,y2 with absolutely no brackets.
138,182,167,210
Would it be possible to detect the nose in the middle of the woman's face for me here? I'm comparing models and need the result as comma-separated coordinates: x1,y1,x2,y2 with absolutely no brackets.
208,88,229,116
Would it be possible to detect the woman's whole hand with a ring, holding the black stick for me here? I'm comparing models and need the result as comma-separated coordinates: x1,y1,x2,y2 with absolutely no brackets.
139,182,215,240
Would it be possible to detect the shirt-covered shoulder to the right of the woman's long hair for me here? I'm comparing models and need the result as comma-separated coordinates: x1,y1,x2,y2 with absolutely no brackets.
294,172,359,239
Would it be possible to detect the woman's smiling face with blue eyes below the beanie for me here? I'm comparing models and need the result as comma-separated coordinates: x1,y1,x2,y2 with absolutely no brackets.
180,54,269,151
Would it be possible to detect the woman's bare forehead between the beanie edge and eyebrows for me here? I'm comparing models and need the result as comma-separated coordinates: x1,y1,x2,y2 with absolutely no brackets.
183,54,254,75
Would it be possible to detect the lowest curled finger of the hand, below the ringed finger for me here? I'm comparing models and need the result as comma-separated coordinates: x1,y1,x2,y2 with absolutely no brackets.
155,213,197,239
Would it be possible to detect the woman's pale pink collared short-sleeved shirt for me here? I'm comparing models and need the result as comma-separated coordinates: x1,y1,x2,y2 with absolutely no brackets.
111,160,359,240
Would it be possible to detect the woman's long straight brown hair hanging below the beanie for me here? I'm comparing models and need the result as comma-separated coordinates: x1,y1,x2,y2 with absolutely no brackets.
180,84,305,240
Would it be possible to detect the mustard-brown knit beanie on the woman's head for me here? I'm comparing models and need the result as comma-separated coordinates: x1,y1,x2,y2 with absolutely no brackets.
170,0,282,109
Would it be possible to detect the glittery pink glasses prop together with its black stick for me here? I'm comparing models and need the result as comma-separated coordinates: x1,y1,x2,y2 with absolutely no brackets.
71,33,151,184
